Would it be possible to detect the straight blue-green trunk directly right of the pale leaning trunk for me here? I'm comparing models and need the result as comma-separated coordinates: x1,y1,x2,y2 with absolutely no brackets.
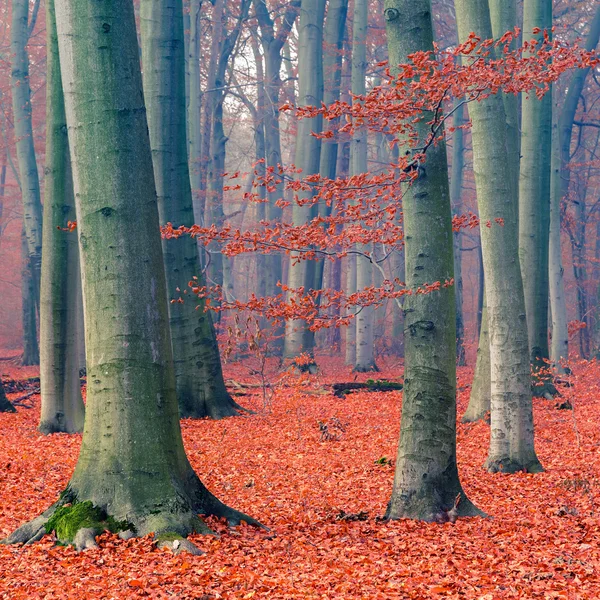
519,0,556,384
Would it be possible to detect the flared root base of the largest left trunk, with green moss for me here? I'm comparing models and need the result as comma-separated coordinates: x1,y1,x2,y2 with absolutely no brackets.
0,475,268,554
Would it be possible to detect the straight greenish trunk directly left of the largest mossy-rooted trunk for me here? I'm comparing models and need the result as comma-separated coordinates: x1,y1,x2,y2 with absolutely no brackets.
38,0,85,434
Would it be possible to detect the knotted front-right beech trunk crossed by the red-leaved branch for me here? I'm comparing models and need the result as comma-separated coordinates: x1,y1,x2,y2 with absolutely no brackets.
384,0,482,521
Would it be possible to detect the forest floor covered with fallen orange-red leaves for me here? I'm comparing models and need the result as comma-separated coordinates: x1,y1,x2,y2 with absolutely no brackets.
0,357,600,600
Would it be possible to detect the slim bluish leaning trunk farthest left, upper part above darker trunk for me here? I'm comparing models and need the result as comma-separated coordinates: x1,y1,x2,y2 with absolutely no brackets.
10,0,42,300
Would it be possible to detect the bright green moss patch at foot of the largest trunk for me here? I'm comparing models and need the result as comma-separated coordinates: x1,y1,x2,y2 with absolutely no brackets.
46,501,133,542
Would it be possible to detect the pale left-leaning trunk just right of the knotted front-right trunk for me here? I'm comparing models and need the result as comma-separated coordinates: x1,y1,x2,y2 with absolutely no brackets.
456,0,542,473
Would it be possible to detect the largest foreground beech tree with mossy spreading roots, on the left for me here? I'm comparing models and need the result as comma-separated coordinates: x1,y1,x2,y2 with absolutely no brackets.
6,0,255,550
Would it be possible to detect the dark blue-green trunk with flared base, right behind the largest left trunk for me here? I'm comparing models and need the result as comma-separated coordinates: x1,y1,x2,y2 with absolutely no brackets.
140,0,241,419
